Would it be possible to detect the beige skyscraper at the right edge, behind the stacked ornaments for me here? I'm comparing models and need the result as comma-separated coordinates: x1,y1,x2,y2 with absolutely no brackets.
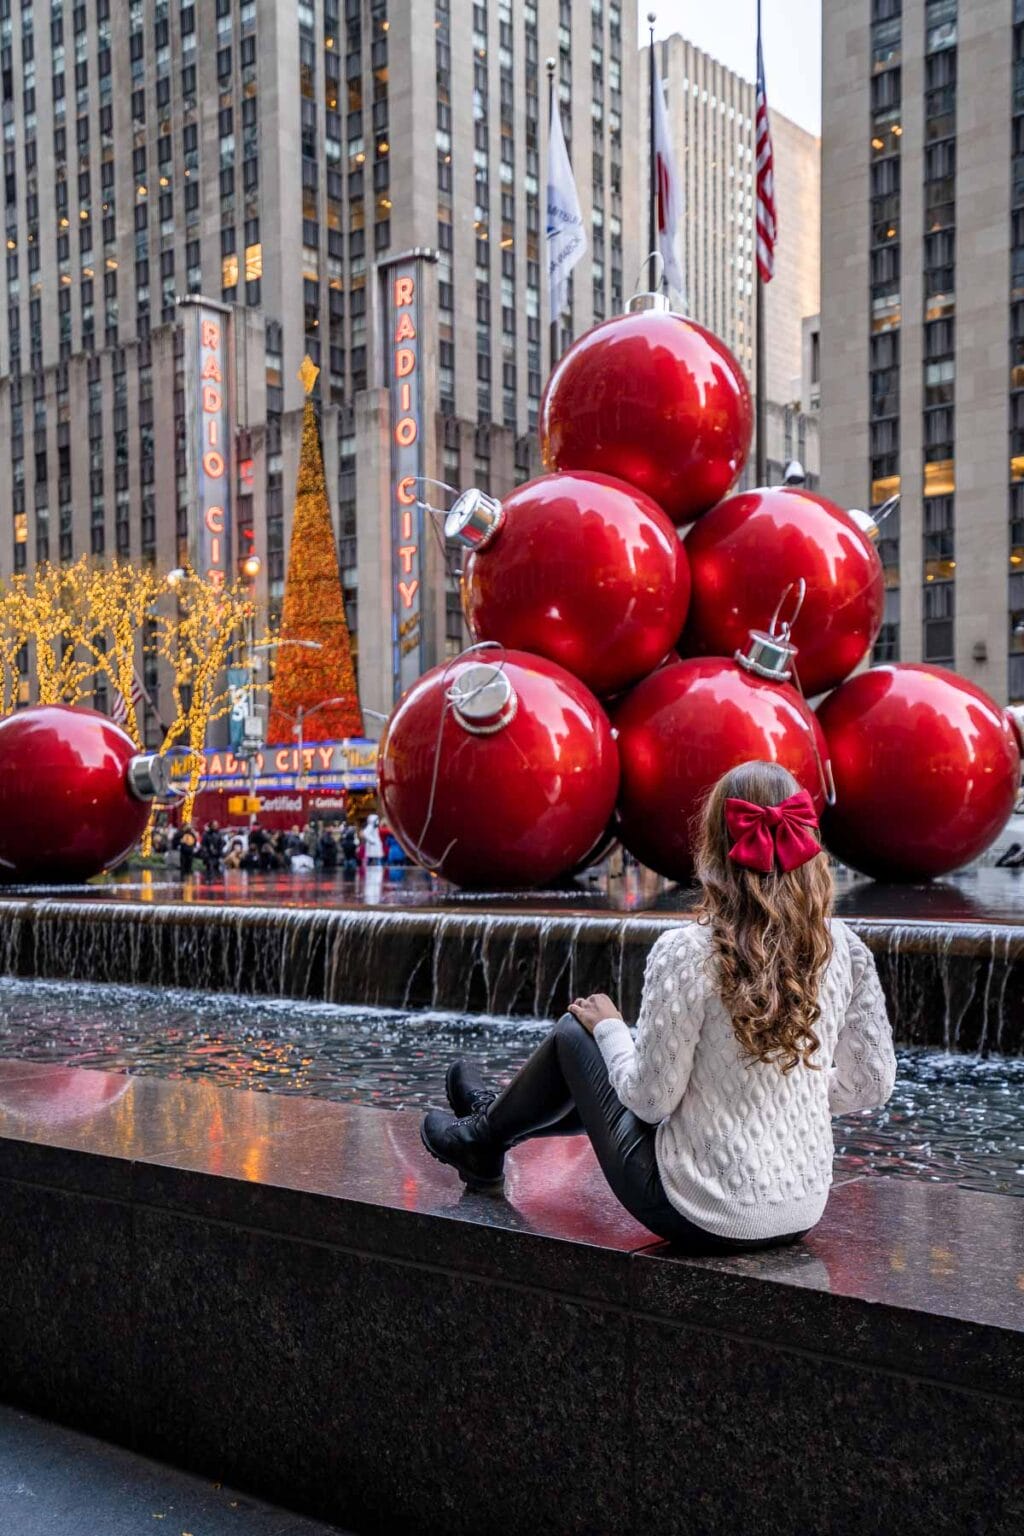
821,0,1024,700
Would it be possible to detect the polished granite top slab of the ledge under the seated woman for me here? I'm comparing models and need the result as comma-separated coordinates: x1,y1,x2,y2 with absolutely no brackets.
0,1061,1024,1395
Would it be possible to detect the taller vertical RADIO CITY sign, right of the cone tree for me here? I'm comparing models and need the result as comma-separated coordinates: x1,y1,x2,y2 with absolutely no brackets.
387,260,425,697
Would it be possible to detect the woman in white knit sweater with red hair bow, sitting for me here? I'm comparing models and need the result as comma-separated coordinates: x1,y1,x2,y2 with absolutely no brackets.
422,762,895,1253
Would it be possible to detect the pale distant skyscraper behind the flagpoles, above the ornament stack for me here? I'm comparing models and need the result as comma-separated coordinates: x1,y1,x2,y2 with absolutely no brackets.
642,35,820,445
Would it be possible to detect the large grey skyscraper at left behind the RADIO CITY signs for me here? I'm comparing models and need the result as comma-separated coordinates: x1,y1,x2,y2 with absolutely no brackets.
0,0,639,730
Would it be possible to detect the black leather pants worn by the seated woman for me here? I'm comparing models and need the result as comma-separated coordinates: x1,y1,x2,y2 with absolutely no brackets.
487,1014,803,1253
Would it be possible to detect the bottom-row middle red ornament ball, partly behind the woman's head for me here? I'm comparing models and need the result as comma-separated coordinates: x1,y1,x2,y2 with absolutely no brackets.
614,656,827,880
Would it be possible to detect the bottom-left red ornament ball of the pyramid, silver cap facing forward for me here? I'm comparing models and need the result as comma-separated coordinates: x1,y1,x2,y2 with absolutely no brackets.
378,648,619,889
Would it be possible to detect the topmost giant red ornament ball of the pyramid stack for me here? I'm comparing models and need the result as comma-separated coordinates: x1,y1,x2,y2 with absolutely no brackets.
540,295,754,524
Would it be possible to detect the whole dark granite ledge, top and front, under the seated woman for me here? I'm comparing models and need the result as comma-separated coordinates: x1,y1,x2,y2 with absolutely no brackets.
0,1063,1024,1536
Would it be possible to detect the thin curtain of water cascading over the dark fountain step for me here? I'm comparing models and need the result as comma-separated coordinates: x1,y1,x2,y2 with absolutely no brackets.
0,899,1024,1054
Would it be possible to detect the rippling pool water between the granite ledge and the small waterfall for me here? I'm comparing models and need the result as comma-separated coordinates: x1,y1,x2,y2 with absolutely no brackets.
0,978,1024,1195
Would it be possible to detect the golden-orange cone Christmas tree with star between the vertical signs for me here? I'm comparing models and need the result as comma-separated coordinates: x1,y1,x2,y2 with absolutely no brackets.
269,358,362,742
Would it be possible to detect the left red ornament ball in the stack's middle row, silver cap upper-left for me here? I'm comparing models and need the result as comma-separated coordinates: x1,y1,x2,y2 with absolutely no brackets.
447,472,689,694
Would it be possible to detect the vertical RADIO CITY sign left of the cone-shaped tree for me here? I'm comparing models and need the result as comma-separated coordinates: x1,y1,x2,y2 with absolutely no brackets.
186,300,232,587
